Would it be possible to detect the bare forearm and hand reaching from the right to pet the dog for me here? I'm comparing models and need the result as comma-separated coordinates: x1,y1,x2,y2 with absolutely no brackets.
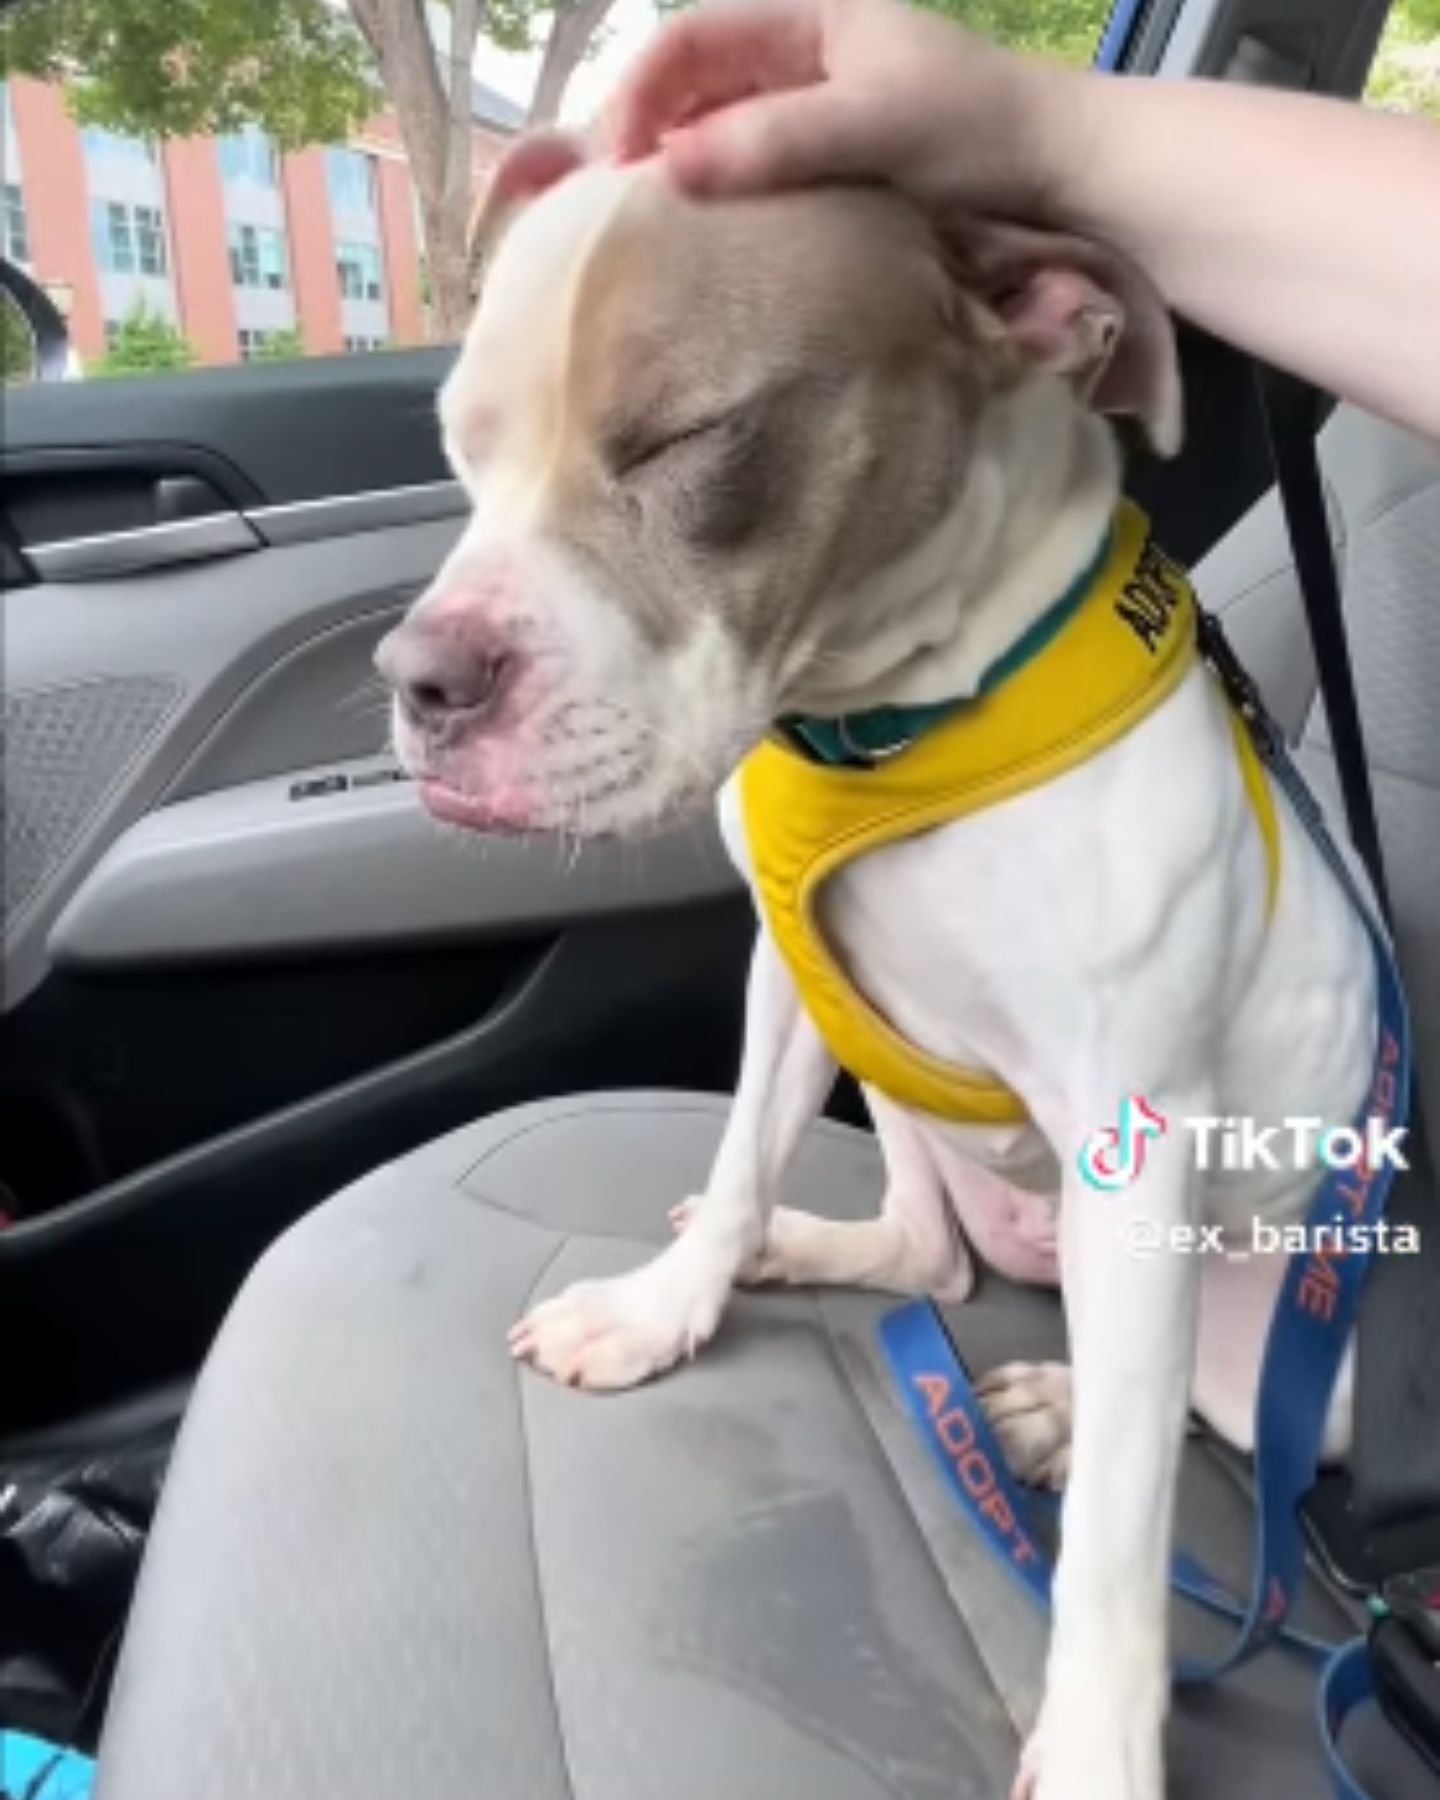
608,0,1440,436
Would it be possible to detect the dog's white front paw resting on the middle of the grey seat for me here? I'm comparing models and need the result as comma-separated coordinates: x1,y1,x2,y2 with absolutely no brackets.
509,1238,731,1390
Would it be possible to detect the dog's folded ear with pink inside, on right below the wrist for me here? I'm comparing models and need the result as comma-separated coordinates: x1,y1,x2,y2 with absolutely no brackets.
945,220,1184,457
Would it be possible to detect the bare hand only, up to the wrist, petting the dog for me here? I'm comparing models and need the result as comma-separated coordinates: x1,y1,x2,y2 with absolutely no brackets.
608,0,1085,218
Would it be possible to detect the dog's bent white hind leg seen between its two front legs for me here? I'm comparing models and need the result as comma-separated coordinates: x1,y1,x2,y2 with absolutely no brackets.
671,1089,976,1300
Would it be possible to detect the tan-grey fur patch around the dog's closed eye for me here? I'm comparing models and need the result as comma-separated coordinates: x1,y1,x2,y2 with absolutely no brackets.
554,170,983,655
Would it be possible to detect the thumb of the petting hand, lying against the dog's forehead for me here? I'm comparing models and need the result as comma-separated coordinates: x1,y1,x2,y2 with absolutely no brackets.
662,86,896,194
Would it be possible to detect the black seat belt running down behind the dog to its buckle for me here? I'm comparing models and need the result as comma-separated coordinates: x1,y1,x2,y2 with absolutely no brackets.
1258,369,1440,1533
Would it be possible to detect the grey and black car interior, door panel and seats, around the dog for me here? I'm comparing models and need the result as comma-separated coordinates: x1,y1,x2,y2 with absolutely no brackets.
0,0,1440,1800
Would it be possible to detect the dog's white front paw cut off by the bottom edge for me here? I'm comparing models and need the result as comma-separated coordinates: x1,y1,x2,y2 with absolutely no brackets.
1010,1681,1165,1800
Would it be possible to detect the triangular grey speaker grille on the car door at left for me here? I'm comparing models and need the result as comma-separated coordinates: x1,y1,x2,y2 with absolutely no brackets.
2,675,182,929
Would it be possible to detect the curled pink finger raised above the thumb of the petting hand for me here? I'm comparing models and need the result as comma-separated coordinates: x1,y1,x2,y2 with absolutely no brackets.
607,0,823,160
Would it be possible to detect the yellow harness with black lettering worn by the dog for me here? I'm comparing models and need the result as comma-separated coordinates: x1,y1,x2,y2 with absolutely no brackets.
740,502,1280,1125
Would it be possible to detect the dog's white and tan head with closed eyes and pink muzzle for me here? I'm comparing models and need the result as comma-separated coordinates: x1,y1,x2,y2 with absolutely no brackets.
380,139,1179,833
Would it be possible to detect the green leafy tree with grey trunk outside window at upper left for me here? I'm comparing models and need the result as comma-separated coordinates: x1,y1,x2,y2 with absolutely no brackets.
0,0,614,337
